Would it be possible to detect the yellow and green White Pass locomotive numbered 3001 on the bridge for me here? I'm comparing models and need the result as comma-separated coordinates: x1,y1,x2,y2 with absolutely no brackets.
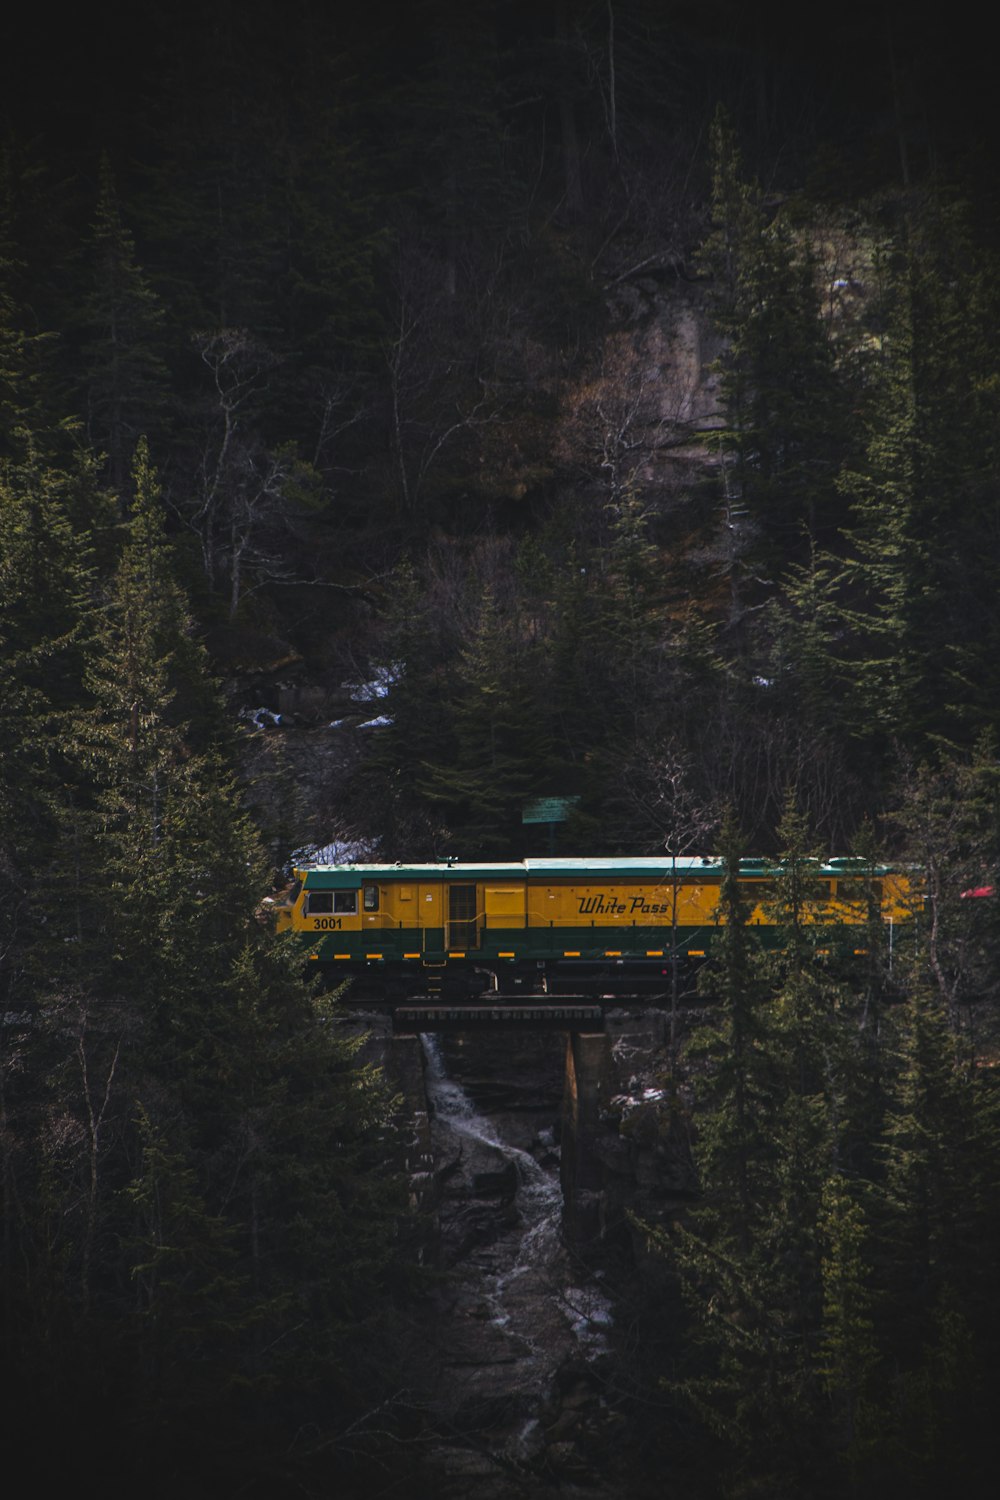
277,857,913,999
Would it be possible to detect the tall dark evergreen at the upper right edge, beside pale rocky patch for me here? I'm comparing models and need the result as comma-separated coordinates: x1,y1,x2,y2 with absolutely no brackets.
840,195,996,743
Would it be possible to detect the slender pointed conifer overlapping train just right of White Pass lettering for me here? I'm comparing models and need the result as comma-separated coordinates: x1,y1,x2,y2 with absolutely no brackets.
663,818,802,1484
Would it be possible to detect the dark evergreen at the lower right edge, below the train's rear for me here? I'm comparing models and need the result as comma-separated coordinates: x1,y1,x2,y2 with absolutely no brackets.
877,989,1000,1494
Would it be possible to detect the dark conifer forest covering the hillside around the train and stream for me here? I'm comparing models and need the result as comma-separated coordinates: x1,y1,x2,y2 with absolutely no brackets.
0,0,1000,1500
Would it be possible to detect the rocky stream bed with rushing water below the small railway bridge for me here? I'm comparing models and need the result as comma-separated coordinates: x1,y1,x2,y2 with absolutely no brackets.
364,1013,701,1500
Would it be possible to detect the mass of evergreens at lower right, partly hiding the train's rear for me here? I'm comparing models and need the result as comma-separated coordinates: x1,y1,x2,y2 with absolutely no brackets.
657,780,1000,1496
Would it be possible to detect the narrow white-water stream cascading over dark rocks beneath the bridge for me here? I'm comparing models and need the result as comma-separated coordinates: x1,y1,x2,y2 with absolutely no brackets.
413,1037,612,1500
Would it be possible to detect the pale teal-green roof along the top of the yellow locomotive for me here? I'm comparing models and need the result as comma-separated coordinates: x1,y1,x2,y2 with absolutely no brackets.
297,855,888,887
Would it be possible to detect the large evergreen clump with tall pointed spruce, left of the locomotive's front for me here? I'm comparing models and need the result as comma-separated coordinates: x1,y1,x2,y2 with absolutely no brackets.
0,444,405,1484
